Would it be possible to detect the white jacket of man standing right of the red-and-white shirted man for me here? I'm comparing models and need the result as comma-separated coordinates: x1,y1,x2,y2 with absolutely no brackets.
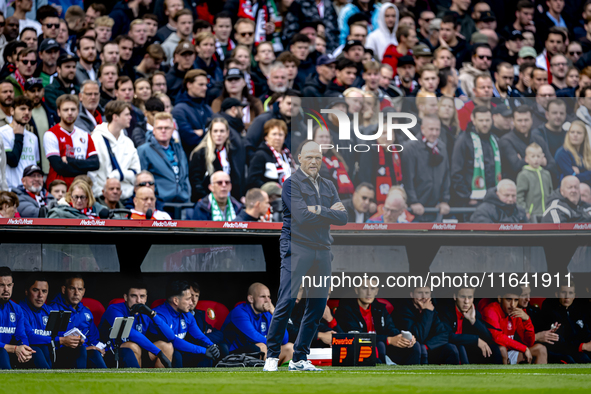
88,122,142,200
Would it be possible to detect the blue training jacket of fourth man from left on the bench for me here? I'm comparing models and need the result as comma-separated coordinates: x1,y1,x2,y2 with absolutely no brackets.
99,302,174,354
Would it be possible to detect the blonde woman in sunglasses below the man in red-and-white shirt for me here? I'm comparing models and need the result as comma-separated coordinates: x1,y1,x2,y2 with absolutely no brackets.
47,180,108,219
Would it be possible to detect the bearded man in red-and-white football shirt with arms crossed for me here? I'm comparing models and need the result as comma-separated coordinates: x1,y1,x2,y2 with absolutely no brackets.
43,94,100,187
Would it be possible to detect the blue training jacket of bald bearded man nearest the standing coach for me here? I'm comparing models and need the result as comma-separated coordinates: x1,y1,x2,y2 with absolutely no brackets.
222,302,289,352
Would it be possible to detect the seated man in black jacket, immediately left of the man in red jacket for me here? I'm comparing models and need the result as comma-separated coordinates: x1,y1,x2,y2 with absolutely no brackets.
440,287,503,365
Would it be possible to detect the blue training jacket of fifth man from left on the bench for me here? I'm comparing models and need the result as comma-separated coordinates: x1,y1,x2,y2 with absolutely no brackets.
149,302,213,354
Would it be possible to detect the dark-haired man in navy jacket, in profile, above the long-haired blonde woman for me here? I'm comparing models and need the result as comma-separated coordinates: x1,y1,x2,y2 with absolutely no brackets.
172,70,212,154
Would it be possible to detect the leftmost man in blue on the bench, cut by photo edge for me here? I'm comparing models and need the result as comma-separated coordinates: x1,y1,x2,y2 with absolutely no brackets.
0,267,35,369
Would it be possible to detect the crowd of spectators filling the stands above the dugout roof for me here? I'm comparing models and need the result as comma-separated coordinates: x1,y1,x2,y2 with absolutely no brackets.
0,0,591,223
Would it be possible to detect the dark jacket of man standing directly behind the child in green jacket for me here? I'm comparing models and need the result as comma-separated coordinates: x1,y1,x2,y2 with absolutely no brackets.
499,130,558,181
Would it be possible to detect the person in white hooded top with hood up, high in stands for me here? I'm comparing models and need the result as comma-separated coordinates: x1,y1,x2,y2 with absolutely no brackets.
365,3,400,61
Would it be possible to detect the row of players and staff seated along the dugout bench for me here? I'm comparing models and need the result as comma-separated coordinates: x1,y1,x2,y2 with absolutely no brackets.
0,267,591,369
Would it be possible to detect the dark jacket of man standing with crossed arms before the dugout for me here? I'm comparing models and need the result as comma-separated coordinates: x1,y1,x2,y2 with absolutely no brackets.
280,169,347,252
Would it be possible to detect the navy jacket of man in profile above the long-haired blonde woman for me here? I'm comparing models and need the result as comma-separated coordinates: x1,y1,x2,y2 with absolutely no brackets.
172,91,213,154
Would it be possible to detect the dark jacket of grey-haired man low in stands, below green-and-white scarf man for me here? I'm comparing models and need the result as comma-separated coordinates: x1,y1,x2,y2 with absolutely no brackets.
470,187,528,223
